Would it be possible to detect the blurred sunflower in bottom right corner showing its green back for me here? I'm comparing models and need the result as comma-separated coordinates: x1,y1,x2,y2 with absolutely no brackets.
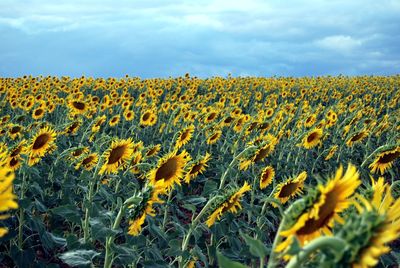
337,178,400,268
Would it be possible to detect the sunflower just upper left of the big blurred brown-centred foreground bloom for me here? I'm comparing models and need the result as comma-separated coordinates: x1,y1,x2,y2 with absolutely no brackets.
273,171,307,206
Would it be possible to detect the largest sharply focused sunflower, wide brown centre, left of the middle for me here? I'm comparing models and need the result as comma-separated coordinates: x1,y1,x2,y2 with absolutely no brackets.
148,151,189,191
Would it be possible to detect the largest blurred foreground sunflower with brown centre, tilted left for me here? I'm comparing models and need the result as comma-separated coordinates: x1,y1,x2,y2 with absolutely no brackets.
276,164,361,252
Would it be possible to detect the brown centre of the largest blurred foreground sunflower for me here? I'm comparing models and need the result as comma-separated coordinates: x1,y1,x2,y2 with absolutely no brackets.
297,191,338,235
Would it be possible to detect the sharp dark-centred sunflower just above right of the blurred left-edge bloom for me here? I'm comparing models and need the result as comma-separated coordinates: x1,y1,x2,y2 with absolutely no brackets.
28,126,57,158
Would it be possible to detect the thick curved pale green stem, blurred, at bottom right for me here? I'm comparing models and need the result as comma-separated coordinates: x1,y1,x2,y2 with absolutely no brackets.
286,237,346,268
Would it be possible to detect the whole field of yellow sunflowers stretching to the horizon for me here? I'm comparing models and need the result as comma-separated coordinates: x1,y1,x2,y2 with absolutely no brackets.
0,74,400,267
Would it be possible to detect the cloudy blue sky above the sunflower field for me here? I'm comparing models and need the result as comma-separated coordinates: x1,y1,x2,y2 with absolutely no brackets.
0,0,400,78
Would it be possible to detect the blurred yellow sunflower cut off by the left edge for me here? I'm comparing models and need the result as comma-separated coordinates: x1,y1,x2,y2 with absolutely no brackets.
0,152,18,237
